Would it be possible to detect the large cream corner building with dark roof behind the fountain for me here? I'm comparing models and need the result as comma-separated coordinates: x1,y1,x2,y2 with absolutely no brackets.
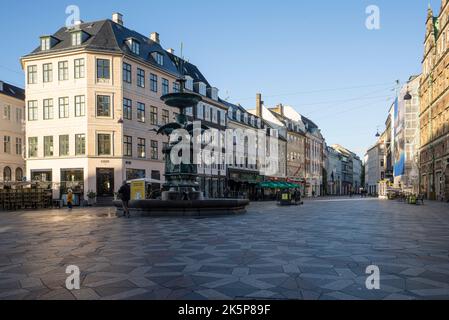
21,14,222,202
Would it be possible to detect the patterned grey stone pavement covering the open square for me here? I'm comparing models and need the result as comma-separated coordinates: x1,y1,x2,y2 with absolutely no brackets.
0,199,449,300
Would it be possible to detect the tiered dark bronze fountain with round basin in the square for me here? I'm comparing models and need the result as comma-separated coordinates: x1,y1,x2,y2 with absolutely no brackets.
114,78,249,217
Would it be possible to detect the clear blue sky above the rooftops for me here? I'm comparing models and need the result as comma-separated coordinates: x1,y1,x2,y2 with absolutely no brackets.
0,0,434,155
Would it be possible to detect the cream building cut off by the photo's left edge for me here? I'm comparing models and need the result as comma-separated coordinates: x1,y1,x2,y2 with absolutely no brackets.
0,80,25,183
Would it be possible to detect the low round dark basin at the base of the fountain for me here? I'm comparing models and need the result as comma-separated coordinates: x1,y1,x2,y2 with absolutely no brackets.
114,199,249,217
